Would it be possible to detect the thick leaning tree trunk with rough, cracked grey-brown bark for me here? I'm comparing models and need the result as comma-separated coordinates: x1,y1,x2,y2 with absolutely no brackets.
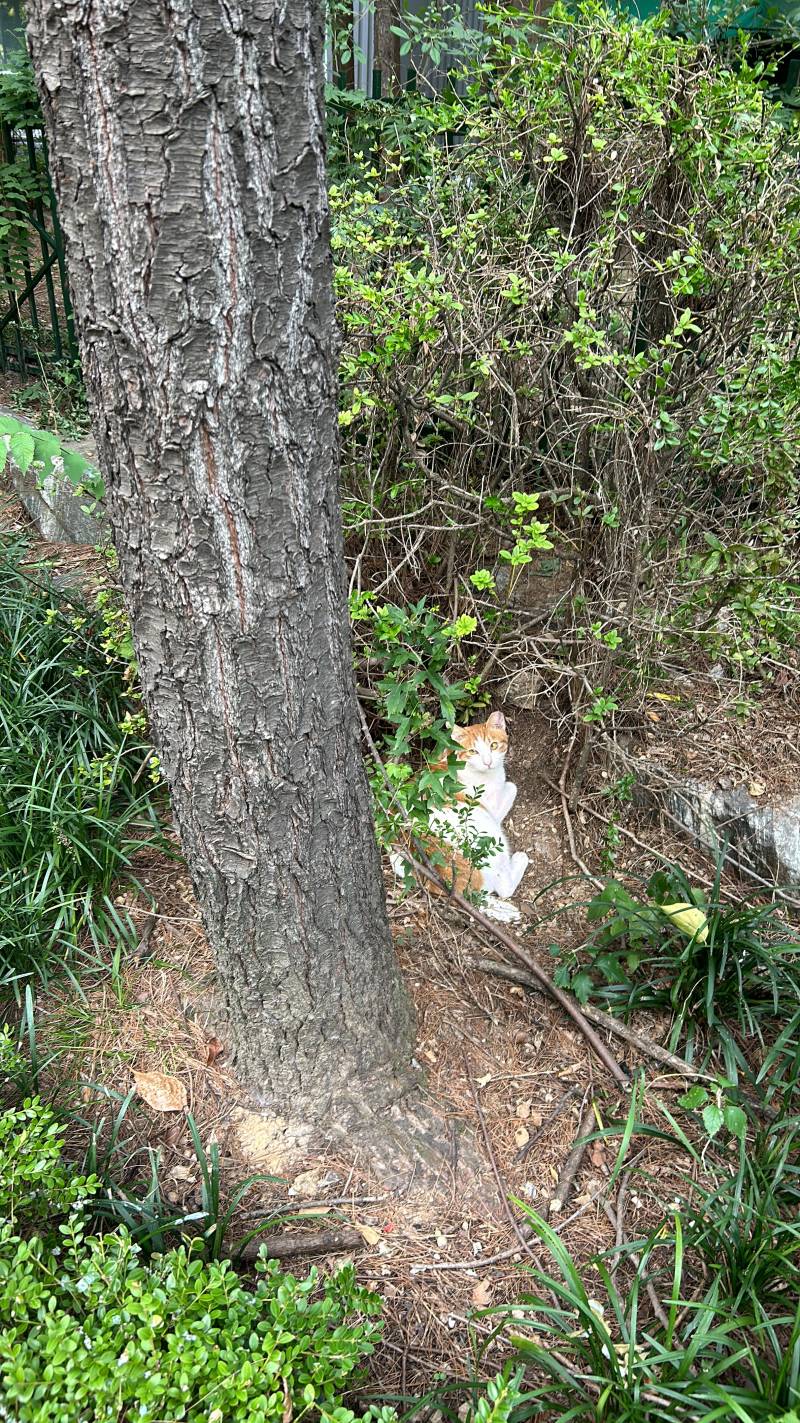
22,0,414,1130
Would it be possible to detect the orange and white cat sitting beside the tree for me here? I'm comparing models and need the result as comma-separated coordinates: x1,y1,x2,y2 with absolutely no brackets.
390,712,528,924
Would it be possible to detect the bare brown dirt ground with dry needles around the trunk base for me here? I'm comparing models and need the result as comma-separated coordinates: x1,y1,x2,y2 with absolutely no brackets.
3,455,791,1396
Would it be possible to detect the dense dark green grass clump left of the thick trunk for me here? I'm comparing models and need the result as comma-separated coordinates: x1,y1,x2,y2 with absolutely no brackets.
0,538,162,985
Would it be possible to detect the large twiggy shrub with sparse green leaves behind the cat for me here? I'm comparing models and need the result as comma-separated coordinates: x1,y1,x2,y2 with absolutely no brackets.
332,0,800,720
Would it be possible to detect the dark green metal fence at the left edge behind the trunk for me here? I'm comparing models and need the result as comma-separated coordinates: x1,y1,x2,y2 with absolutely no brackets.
0,124,78,376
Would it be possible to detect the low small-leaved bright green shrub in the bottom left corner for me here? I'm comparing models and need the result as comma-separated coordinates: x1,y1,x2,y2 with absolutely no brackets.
0,1220,390,1423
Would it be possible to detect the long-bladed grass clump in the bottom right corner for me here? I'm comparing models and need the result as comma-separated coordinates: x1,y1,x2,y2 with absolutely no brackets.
483,1192,800,1423
